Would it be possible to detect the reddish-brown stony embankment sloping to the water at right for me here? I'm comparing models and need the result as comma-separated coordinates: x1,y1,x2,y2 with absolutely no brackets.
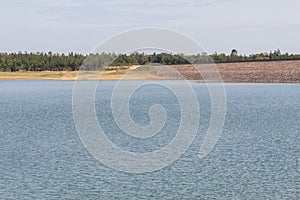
155,61,300,83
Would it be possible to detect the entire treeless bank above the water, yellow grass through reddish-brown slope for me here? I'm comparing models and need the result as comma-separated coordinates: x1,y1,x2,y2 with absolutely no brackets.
0,61,300,83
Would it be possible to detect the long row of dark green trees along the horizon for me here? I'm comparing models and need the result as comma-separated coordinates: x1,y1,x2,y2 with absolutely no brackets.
0,49,300,72
